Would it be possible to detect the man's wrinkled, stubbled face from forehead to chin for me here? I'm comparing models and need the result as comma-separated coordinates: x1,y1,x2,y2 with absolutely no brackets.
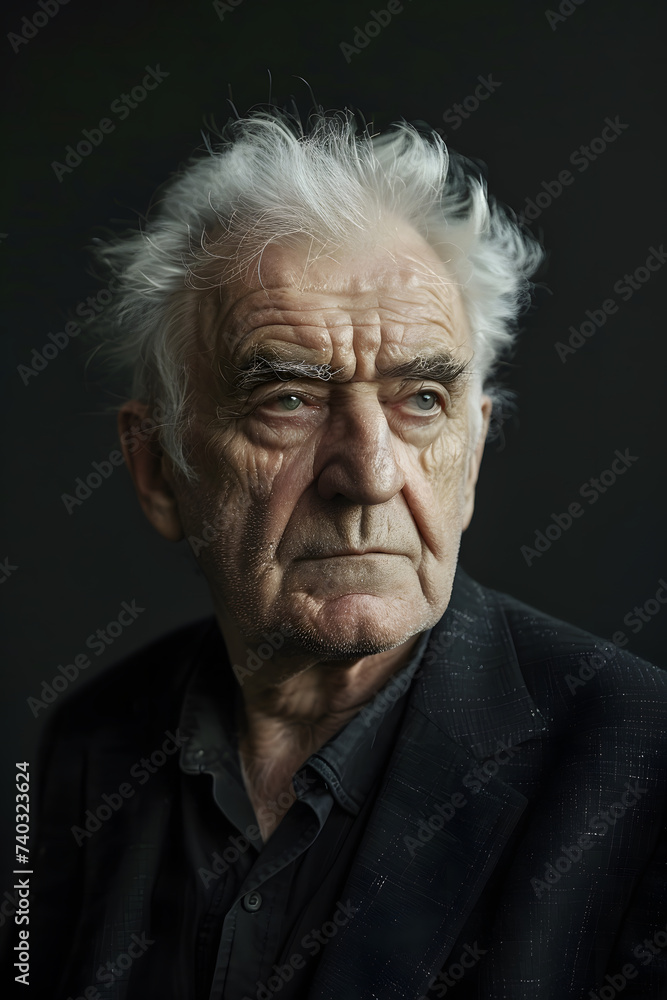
161,229,488,660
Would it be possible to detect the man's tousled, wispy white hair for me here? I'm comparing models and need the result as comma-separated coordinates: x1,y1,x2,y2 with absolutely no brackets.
96,107,543,478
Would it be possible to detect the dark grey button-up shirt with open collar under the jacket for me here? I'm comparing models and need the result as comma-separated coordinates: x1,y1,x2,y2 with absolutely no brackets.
175,628,430,1000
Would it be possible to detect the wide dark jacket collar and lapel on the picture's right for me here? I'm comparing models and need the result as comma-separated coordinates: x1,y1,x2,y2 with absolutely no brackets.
309,570,546,1000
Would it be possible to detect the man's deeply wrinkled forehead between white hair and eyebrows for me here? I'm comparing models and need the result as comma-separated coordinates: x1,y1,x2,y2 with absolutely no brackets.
196,227,471,368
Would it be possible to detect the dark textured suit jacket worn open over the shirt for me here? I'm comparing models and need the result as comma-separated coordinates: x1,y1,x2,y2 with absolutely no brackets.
26,570,667,1000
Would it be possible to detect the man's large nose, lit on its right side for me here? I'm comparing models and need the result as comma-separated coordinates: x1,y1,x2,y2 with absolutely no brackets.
315,397,405,505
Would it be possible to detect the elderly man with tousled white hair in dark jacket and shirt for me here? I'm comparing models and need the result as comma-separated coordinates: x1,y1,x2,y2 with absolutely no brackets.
32,108,667,1000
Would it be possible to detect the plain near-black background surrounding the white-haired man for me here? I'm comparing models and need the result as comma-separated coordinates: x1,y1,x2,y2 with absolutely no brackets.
0,0,667,952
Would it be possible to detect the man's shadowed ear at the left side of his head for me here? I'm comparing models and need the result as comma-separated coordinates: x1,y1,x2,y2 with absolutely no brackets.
118,399,183,542
